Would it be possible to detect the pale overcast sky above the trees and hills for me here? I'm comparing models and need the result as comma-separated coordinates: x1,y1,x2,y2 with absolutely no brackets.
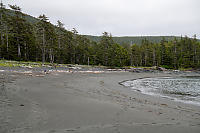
3,0,200,38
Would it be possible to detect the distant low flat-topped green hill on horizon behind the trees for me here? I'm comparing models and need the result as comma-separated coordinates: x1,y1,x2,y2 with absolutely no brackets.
85,35,183,44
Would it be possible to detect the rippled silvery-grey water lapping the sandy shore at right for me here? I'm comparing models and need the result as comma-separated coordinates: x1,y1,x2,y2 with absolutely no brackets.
123,76,200,106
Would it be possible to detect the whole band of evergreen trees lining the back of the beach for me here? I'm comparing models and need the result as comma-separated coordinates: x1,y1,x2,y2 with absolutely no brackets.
0,3,200,69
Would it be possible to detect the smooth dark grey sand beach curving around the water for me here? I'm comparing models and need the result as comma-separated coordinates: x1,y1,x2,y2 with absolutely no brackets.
0,72,200,133
